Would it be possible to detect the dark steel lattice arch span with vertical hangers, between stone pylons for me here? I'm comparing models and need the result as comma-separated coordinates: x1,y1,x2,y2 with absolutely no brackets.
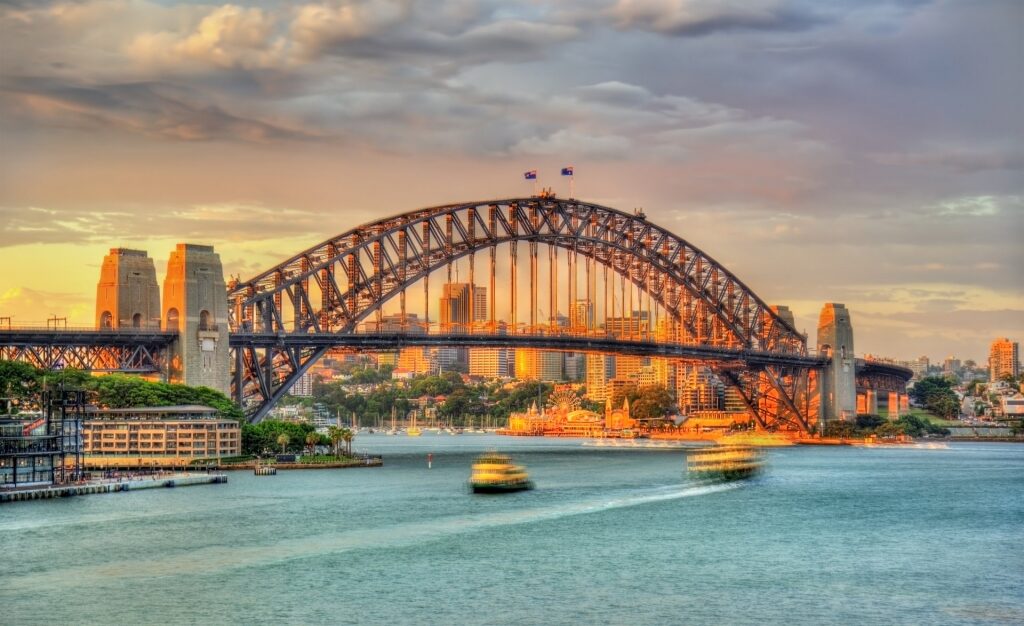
228,196,825,430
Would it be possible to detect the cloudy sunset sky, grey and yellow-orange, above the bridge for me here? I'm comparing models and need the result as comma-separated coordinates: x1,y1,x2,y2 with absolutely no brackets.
0,0,1024,363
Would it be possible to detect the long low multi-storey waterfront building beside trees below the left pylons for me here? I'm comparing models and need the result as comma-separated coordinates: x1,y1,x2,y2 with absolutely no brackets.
82,405,242,467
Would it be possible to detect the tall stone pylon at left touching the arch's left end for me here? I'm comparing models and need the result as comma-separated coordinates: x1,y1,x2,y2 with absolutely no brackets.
164,244,230,394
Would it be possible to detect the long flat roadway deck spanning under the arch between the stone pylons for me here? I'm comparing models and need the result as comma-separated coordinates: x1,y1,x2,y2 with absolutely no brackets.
230,333,826,368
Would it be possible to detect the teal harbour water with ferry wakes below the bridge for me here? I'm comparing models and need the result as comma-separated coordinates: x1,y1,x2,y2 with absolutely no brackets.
0,432,1024,624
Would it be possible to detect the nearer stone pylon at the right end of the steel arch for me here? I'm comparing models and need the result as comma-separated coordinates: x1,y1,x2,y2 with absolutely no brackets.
818,302,857,422
